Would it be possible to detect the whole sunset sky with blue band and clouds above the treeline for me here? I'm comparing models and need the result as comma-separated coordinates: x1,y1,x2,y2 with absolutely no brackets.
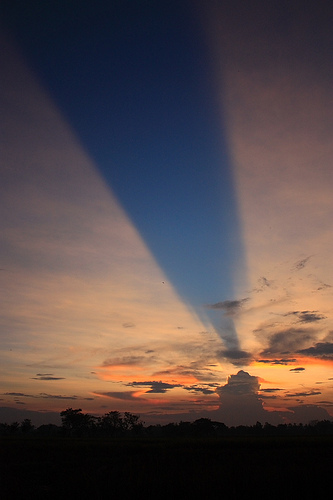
0,0,333,425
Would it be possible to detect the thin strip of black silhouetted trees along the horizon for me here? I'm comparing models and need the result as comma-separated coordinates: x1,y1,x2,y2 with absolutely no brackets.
0,408,333,438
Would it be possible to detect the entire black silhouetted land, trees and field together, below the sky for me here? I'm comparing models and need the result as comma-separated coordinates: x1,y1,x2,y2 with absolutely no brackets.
0,408,333,500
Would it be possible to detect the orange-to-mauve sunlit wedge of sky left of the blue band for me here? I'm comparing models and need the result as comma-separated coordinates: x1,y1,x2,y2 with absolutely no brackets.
0,34,231,410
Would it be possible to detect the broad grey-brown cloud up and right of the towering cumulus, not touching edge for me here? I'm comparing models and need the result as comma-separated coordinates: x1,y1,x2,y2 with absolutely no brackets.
261,328,315,356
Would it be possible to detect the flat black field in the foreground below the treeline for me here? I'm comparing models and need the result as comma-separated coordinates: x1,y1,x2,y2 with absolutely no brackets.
0,436,333,500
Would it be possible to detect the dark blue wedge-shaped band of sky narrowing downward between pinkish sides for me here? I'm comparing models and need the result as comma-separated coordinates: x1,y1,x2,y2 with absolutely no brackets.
4,0,240,316
